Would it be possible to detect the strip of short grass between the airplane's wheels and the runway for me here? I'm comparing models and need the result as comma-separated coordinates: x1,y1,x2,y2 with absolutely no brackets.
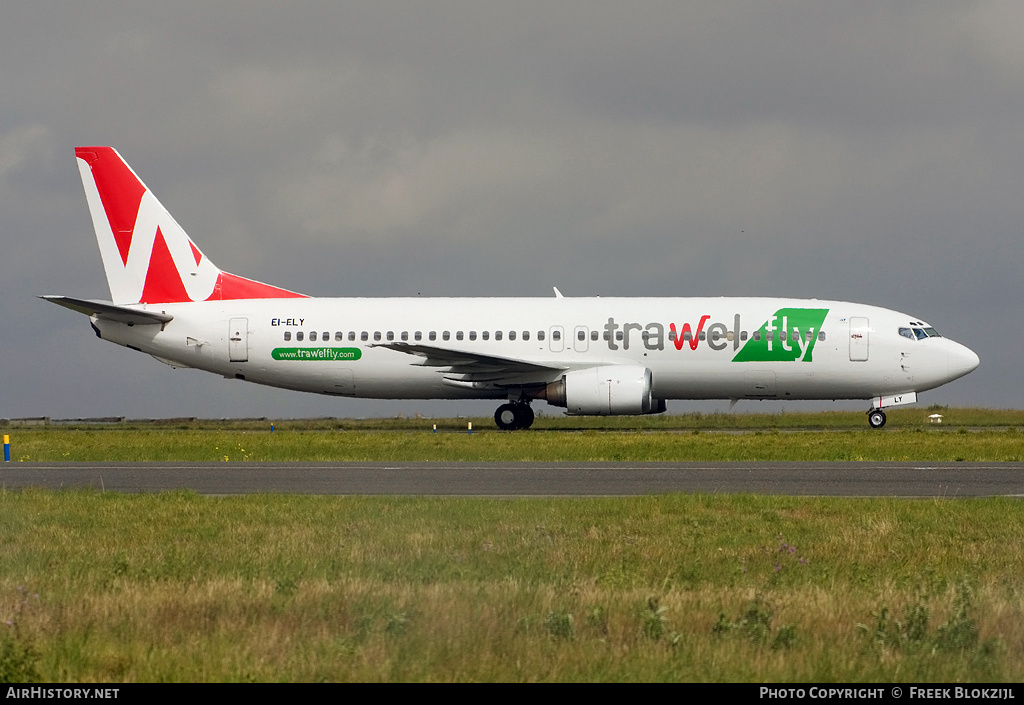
2,424,1024,462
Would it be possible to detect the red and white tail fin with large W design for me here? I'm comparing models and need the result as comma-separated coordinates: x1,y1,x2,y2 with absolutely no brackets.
75,147,302,303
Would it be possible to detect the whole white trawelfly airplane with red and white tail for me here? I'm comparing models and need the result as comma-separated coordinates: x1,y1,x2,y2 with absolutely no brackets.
42,147,979,430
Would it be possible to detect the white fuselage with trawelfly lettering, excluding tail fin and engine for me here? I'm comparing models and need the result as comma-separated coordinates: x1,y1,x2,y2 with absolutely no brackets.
93,297,978,408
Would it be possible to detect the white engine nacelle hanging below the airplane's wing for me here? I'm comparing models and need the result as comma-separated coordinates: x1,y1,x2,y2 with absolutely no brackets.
545,365,665,416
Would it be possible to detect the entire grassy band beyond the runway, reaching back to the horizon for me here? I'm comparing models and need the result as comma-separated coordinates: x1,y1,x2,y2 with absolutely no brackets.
5,409,1024,462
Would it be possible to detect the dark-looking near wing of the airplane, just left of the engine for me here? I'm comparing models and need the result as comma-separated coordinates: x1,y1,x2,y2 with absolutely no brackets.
373,342,569,386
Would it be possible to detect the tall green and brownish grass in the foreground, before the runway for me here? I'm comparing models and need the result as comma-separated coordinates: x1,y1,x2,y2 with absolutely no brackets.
0,491,1024,681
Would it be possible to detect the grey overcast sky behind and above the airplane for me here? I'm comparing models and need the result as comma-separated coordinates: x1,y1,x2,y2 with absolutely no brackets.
0,0,1024,418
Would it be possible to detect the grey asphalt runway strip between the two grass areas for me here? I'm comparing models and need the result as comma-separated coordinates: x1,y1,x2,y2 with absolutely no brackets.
0,462,1024,498
